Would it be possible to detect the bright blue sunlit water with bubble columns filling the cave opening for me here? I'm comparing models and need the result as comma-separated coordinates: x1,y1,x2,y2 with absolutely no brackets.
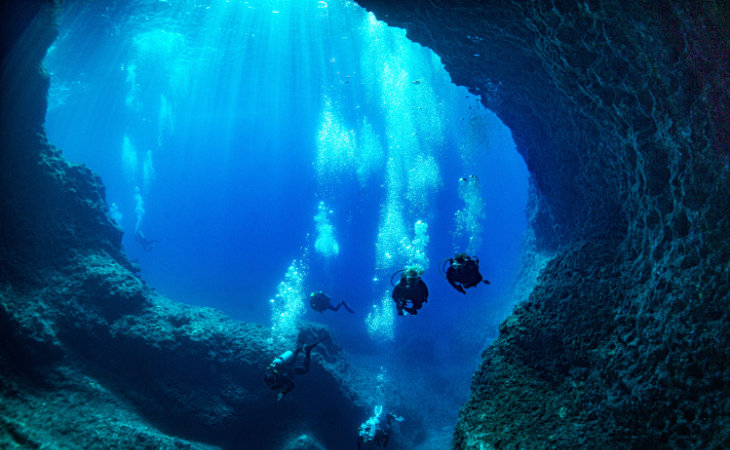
45,0,527,446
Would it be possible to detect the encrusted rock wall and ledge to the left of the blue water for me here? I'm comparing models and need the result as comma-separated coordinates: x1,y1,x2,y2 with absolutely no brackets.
0,1,370,449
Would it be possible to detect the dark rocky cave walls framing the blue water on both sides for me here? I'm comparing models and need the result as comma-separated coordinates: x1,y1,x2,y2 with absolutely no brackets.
0,0,730,448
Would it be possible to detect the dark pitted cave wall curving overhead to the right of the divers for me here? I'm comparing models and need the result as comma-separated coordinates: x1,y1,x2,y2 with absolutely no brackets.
358,0,730,448
